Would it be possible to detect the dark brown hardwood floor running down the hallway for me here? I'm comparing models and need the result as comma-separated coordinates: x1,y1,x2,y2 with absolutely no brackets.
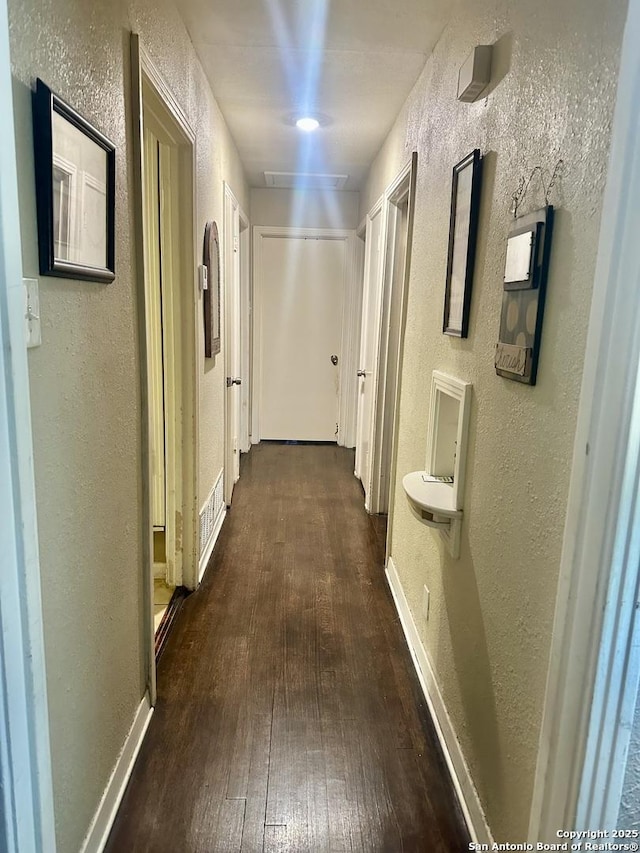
106,443,469,853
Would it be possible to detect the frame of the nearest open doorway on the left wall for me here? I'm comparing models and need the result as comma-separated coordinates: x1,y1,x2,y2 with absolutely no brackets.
131,33,201,704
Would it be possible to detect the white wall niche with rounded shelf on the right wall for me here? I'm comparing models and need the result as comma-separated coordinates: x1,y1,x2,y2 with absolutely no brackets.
402,370,471,558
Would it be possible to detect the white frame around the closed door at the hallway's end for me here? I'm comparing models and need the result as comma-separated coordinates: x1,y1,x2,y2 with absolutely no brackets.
251,225,360,447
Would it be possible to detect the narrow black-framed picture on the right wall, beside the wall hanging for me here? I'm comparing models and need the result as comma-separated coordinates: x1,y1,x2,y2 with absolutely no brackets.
442,148,482,338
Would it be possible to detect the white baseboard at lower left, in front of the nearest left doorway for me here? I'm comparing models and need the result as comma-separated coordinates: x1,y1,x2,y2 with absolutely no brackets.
81,694,153,853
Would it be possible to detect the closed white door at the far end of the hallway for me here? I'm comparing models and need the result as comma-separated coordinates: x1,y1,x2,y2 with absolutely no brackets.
259,235,347,441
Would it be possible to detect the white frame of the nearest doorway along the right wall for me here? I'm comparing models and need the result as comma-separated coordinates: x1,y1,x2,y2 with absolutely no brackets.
369,151,418,512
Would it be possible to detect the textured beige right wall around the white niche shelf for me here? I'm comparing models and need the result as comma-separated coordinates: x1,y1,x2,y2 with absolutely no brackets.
361,0,626,841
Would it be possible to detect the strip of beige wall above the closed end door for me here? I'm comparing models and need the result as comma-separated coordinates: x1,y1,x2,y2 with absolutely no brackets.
250,188,360,229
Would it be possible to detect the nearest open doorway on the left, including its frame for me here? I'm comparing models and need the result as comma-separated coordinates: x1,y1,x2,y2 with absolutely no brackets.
132,36,198,695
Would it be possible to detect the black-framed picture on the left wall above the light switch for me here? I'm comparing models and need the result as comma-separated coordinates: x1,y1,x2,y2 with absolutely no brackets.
33,79,116,283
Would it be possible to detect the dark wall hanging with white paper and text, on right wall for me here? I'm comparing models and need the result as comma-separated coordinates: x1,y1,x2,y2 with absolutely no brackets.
494,205,553,385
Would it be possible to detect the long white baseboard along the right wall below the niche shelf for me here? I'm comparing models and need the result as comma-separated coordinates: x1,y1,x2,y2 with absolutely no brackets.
386,557,493,849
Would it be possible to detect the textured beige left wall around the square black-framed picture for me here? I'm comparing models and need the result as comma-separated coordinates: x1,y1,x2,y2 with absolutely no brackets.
9,0,249,853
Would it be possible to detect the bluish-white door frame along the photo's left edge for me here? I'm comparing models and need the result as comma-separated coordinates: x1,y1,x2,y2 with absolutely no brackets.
0,0,56,853
